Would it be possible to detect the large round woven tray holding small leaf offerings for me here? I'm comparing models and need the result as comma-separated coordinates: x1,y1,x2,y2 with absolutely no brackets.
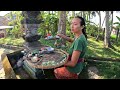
26,49,68,69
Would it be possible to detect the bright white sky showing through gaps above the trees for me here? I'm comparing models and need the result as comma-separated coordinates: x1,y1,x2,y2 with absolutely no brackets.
0,11,120,27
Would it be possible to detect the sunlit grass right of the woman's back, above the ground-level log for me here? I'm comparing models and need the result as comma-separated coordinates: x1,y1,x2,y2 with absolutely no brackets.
87,37,120,58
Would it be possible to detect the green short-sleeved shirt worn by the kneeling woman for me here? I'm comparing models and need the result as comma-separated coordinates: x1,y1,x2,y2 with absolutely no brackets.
67,34,87,73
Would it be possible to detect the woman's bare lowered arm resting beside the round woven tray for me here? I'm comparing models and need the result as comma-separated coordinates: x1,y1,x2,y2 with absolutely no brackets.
64,50,81,67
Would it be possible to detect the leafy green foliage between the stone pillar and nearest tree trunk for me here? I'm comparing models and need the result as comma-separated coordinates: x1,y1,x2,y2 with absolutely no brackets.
38,12,58,35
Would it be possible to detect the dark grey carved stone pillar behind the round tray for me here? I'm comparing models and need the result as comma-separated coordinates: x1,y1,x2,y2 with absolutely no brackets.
21,11,41,50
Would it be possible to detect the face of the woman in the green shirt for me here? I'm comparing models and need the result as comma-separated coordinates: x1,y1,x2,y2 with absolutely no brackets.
71,18,83,33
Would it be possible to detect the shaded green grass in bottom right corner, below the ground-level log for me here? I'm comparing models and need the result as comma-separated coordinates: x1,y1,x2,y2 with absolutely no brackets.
89,61,120,79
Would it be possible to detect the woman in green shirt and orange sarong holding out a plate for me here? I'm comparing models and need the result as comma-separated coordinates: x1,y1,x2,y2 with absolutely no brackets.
54,16,87,79
